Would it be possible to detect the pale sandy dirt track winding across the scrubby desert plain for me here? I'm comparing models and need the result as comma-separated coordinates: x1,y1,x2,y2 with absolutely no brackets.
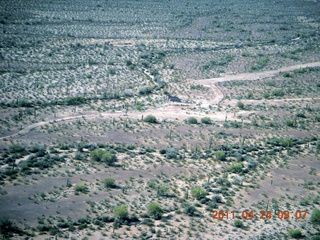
0,62,320,141
